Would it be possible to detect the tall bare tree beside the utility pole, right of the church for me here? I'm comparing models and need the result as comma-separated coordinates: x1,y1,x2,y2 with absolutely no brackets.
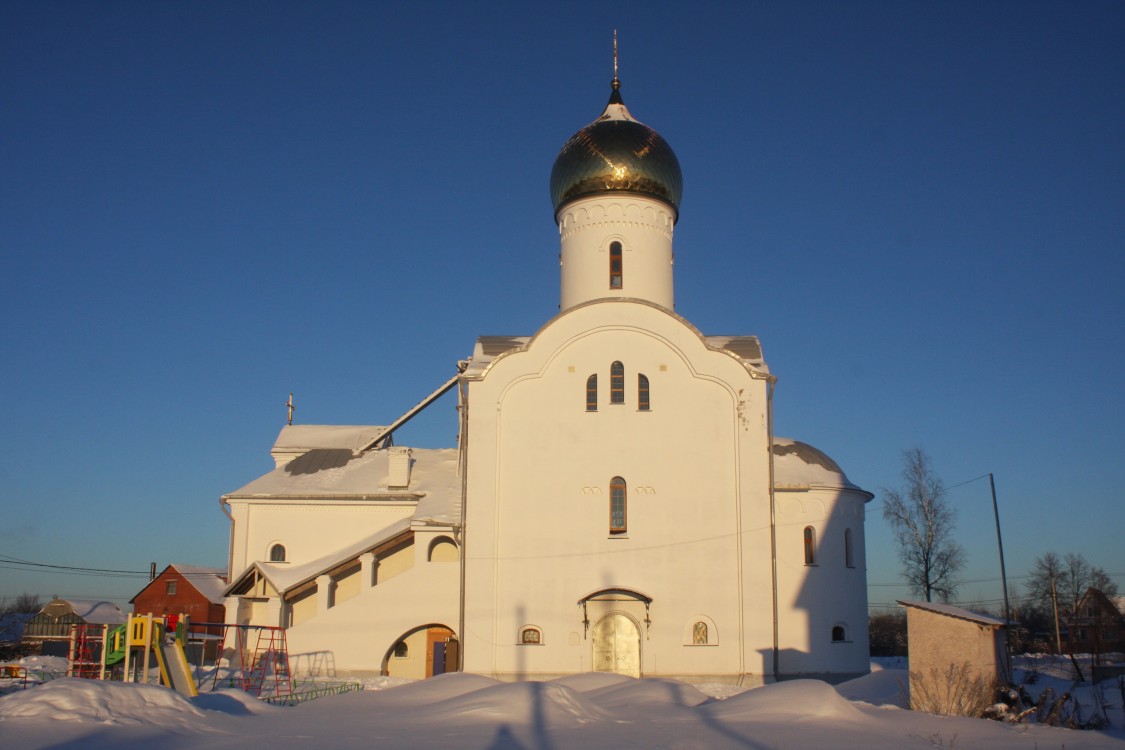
883,448,965,602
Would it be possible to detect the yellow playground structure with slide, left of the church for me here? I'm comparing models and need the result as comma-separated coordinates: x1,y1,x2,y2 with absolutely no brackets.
66,614,199,697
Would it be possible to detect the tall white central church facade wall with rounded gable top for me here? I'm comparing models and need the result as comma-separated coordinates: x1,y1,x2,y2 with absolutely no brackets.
464,299,772,679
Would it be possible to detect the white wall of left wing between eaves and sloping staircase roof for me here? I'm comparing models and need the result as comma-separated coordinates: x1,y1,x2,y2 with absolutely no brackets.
230,498,416,576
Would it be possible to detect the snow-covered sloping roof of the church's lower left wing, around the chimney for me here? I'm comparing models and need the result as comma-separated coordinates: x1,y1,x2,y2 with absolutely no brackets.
225,448,461,503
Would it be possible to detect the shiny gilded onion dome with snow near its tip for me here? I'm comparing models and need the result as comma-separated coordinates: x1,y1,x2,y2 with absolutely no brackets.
551,79,684,222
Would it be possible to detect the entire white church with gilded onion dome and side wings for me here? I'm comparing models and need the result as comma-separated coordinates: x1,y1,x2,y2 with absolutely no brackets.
222,71,872,684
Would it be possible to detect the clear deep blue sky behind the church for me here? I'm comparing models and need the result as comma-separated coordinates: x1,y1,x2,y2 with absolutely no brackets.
0,0,1125,603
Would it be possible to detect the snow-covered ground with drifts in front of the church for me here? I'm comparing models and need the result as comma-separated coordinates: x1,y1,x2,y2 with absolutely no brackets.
0,660,1125,750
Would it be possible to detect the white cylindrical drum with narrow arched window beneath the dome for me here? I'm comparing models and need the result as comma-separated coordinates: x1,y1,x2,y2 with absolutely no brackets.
558,193,674,310
